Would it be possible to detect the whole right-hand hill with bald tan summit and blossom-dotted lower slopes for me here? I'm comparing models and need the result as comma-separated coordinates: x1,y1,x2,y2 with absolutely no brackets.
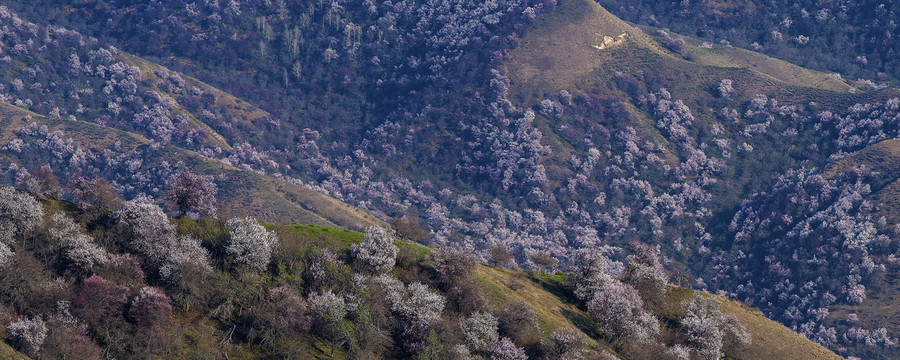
507,0,900,357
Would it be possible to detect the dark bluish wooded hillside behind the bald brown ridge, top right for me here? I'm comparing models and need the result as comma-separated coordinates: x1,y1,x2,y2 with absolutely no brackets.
598,0,898,84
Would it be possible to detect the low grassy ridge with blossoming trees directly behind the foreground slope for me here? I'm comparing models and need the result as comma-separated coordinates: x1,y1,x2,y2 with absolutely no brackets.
0,103,384,229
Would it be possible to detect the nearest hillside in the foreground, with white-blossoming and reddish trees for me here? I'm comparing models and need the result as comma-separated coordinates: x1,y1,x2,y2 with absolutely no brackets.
0,187,836,359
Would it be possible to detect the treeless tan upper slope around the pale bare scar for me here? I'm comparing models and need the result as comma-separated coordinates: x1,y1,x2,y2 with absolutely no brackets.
507,0,850,103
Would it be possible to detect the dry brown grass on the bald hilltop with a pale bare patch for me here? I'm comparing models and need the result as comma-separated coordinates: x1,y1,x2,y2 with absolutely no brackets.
506,0,866,111
